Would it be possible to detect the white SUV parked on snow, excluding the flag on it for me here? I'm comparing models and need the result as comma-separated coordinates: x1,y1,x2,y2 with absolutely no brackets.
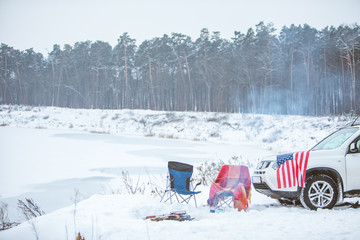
252,122,360,210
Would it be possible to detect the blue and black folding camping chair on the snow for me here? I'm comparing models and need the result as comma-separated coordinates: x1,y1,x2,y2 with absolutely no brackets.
161,162,201,207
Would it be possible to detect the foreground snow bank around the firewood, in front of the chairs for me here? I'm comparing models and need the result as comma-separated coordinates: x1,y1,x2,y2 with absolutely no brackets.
0,195,360,240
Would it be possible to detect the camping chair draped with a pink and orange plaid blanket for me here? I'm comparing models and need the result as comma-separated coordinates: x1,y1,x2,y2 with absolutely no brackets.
208,165,251,211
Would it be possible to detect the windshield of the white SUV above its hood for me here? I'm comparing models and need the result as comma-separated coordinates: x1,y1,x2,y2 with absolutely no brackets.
312,128,359,150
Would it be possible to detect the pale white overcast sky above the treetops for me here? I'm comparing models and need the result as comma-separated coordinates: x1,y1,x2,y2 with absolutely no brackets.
0,0,360,56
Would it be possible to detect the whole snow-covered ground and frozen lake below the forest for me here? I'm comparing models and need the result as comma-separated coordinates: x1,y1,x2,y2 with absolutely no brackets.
0,105,360,240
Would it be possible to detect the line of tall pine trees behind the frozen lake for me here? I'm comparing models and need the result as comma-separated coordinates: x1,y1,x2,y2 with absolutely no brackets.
0,22,360,115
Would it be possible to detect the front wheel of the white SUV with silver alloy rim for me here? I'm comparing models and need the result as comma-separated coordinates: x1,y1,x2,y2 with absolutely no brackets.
300,174,338,210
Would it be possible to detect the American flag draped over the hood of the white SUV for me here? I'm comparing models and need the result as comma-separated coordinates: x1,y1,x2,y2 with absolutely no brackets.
276,151,310,188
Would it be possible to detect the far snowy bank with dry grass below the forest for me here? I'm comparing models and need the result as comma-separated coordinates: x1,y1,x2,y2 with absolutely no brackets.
0,105,350,152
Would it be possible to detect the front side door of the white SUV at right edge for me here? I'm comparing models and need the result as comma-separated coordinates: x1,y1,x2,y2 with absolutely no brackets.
346,136,360,191
